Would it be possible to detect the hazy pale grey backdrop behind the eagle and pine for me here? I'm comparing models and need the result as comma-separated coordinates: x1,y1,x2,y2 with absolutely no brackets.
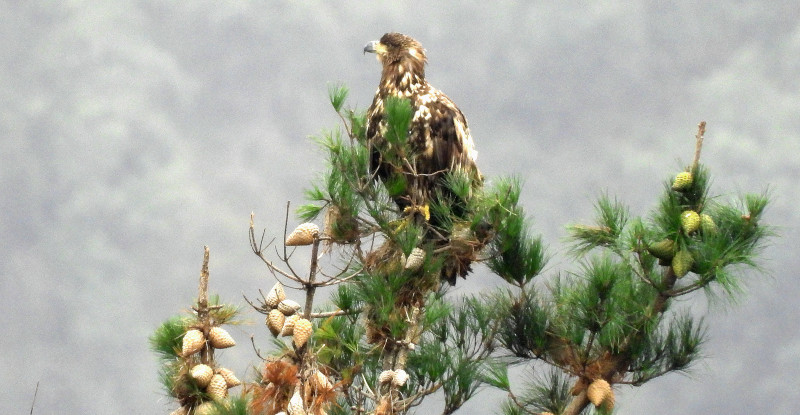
0,1,800,414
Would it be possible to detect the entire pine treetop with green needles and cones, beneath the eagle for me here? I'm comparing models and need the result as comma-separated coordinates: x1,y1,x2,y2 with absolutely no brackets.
151,87,771,415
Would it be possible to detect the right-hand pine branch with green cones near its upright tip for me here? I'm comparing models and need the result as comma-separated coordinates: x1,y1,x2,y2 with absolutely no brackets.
487,123,771,415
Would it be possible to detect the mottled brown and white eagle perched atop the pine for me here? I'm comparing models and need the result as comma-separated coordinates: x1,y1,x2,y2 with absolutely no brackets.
364,33,483,283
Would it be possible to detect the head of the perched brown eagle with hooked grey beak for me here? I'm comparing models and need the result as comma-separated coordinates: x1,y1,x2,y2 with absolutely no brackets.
364,33,427,77
